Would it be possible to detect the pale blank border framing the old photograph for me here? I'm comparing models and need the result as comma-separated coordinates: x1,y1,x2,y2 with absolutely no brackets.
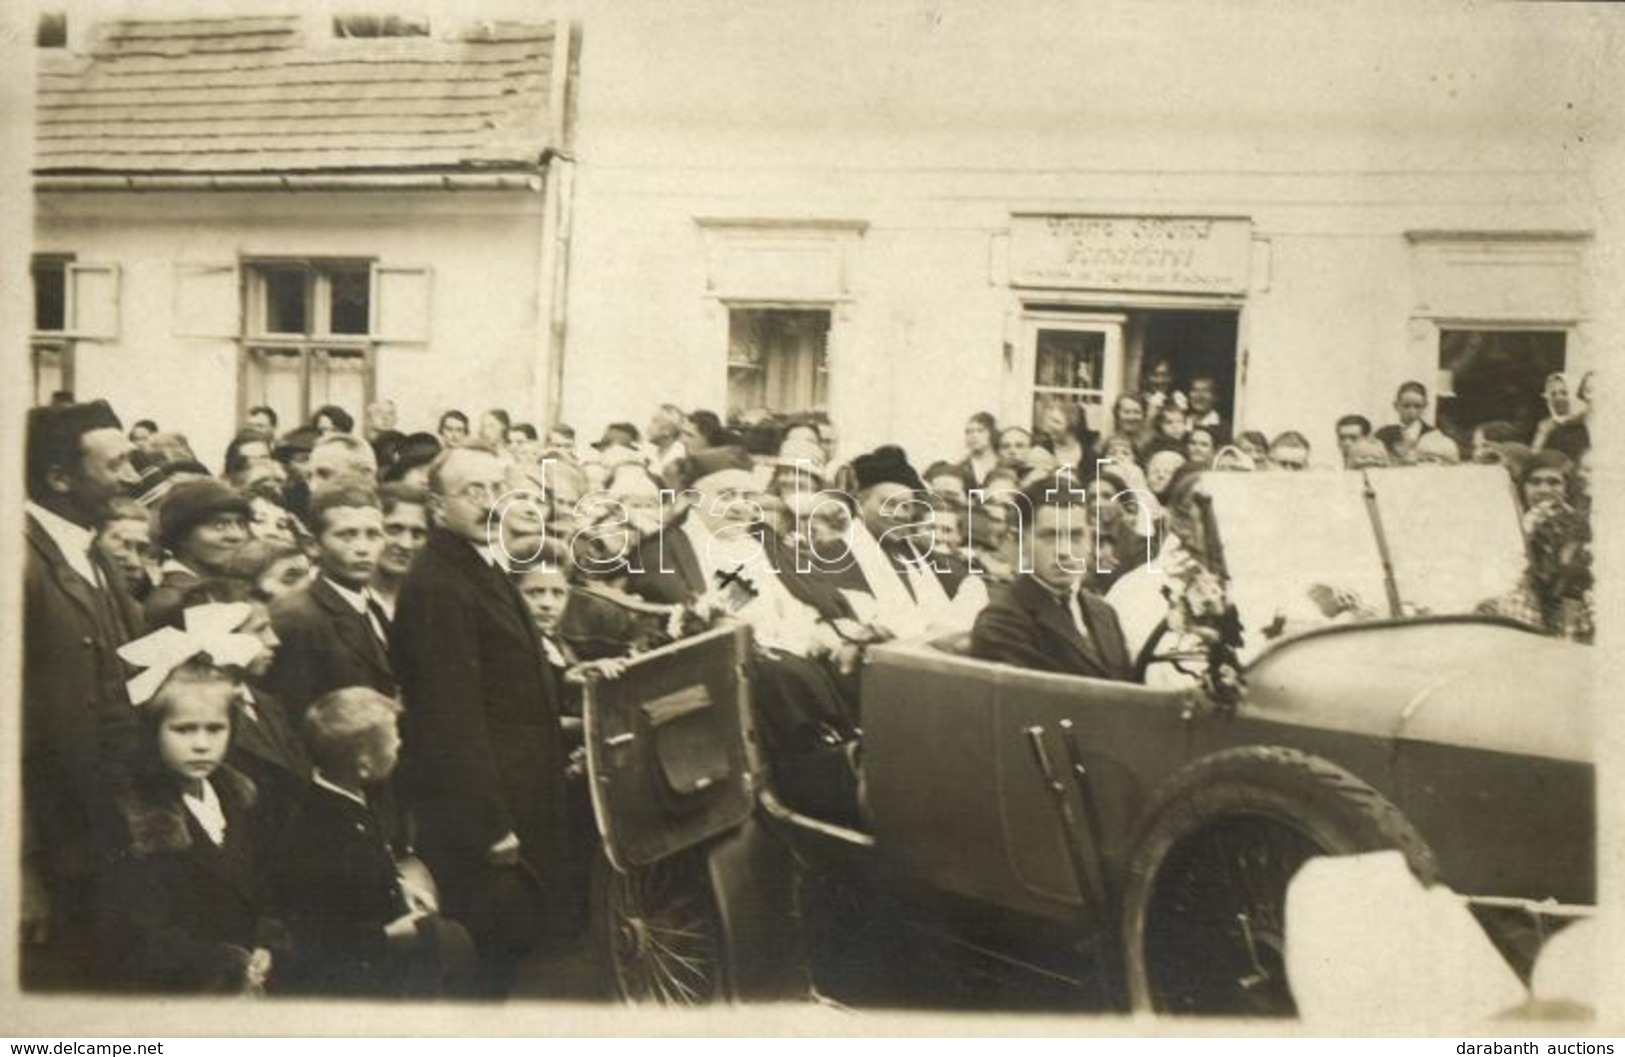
0,0,1625,1039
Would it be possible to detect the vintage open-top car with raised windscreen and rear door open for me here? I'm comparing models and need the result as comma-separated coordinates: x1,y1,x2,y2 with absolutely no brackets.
587,467,1596,1013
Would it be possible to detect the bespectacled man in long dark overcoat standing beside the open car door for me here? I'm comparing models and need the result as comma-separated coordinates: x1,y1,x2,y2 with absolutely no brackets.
392,444,575,994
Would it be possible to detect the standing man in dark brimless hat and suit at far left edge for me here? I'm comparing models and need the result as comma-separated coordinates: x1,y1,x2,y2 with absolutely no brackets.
21,400,143,989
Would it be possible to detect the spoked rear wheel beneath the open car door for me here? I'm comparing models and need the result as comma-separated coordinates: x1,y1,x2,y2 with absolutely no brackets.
593,855,725,1005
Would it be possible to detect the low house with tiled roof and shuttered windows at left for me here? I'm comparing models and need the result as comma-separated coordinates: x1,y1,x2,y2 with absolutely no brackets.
31,16,572,462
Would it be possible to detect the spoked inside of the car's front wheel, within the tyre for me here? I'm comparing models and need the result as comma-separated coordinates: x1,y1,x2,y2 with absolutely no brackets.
1144,816,1329,1016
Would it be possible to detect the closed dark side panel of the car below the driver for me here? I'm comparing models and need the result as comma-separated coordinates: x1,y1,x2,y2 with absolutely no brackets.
863,634,1188,920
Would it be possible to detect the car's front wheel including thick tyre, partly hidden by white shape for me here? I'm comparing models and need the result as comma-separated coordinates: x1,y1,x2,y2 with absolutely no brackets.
1121,746,1438,1016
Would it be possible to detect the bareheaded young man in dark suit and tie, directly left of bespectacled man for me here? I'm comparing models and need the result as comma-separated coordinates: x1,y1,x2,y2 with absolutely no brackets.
265,483,395,717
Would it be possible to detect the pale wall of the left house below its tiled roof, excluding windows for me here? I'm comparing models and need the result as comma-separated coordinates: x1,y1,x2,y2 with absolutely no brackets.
34,190,546,465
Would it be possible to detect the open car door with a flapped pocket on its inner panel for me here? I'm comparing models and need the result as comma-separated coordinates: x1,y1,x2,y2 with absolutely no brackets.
582,626,756,872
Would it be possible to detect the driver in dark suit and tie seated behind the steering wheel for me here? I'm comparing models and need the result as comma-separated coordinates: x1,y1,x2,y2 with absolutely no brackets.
970,478,1134,680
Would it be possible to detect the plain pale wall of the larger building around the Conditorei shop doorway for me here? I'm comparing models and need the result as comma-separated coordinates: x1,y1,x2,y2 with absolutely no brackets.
564,0,1607,462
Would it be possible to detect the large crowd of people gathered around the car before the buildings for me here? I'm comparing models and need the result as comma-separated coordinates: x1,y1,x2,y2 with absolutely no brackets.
23,354,1593,997
